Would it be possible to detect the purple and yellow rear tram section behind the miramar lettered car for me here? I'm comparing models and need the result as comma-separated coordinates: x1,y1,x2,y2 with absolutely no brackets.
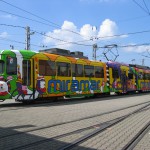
107,62,150,94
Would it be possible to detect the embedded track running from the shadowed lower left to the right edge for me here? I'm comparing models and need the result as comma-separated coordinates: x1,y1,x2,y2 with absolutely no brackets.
0,103,150,150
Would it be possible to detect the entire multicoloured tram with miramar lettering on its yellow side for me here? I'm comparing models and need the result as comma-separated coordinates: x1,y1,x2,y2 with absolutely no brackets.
0,49,150,102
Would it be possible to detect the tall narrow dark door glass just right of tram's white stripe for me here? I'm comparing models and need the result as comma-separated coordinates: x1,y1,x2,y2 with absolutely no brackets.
22,60,31,85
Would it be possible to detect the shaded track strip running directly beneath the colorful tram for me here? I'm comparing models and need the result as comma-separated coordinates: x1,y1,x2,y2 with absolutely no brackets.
0,93,149,112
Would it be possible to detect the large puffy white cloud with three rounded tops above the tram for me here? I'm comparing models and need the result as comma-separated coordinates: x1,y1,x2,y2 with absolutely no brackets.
43,19,118,48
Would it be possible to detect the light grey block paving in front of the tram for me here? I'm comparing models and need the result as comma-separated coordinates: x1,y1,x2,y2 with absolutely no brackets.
0,94,150,150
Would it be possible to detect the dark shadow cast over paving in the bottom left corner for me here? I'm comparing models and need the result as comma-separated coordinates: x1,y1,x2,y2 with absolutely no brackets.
0,125,94,150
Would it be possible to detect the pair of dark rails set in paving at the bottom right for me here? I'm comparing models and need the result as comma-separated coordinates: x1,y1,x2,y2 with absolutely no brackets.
60,105,150,150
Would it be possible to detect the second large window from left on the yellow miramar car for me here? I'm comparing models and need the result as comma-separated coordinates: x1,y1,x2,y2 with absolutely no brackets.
57,62,71,77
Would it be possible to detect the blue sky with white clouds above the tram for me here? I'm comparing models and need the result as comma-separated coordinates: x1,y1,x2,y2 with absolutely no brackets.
0,0,150,66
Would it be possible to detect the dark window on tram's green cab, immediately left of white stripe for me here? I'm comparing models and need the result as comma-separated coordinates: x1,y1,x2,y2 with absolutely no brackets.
6,57,17,75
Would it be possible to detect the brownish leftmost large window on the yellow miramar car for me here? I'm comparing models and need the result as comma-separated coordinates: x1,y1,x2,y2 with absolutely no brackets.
39,60,56,76
